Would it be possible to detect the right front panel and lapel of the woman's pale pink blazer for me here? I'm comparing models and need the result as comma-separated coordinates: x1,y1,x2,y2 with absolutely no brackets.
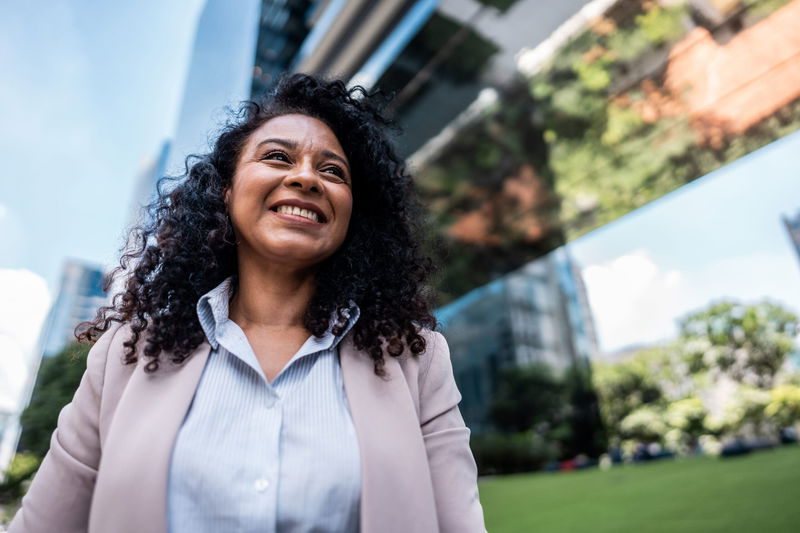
339,335,438,533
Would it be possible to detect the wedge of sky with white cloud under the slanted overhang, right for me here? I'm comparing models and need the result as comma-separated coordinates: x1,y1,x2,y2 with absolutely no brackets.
569,132,800,353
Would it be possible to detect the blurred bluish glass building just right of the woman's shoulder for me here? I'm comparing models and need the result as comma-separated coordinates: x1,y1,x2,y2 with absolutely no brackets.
436,248,597,432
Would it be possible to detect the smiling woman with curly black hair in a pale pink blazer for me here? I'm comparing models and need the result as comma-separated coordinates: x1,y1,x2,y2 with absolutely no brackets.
10,75,484,533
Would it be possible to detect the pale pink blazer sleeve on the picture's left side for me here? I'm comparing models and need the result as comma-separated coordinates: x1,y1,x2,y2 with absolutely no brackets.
8,324,120,533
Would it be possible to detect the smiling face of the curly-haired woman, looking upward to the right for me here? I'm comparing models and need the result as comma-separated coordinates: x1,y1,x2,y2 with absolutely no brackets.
225,114,353,269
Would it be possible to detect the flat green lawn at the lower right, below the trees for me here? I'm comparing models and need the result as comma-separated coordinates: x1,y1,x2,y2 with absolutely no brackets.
480,446,800,533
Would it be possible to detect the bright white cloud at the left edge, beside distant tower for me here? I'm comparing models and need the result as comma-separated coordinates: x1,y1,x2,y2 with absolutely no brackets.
0,269,50,409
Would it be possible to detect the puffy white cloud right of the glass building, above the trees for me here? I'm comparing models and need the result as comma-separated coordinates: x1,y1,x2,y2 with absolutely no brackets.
583,250,686,352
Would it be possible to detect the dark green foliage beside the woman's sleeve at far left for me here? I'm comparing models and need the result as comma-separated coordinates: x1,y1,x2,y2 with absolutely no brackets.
19,344,90,457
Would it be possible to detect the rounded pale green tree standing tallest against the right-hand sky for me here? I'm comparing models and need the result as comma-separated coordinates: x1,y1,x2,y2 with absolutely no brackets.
679,301,798,389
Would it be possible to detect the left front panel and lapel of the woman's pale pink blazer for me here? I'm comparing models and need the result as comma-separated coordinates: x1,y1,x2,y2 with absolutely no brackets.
89,342,210,533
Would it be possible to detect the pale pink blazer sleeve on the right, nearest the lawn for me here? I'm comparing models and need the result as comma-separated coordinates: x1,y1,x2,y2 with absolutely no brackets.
419,332,486,533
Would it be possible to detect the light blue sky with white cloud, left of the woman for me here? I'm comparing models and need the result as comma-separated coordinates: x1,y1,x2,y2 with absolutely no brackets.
0,0,203,409
